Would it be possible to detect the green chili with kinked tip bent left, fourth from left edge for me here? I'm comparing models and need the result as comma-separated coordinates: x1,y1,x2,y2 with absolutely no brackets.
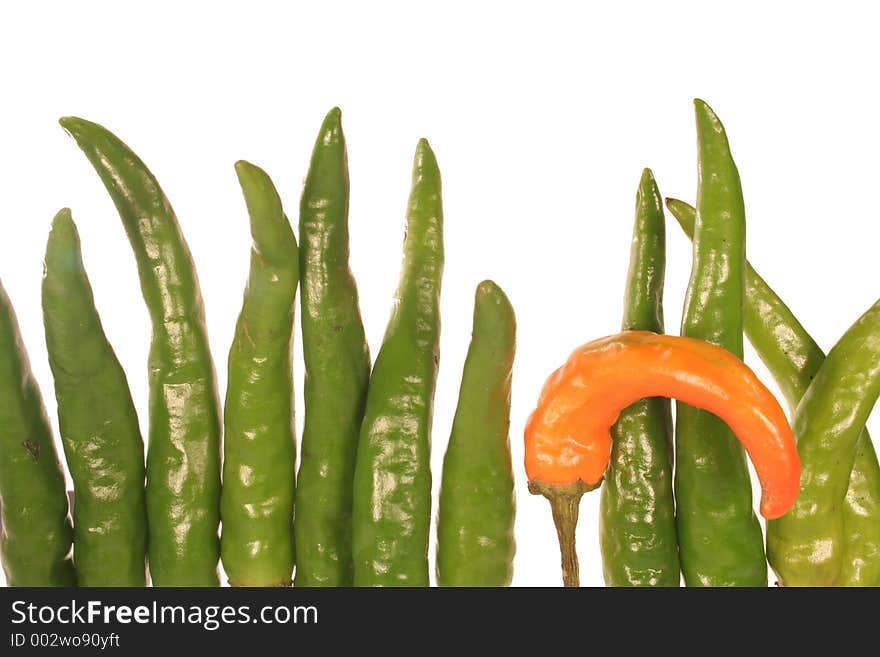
220,161,299,586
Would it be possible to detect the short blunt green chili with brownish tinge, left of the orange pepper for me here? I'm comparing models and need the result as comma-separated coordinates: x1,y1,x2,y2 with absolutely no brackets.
437,281,516,586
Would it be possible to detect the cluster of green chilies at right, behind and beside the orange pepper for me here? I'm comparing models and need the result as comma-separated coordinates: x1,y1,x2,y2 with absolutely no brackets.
600,100,880,586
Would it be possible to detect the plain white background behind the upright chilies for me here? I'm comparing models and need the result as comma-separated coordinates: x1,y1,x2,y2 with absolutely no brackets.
0,0,880,585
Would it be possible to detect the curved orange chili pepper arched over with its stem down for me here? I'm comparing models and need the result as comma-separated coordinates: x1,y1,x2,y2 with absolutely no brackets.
525,331,800,585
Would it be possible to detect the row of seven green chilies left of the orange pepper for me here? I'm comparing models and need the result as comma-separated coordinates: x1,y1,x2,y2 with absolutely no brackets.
0,109,516,586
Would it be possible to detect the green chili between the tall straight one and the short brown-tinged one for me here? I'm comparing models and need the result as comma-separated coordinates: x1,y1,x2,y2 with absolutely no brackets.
353,139,443,586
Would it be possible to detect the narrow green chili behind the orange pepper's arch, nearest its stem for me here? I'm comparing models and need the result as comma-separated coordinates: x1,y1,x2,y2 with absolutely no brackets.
599,169,681,586
